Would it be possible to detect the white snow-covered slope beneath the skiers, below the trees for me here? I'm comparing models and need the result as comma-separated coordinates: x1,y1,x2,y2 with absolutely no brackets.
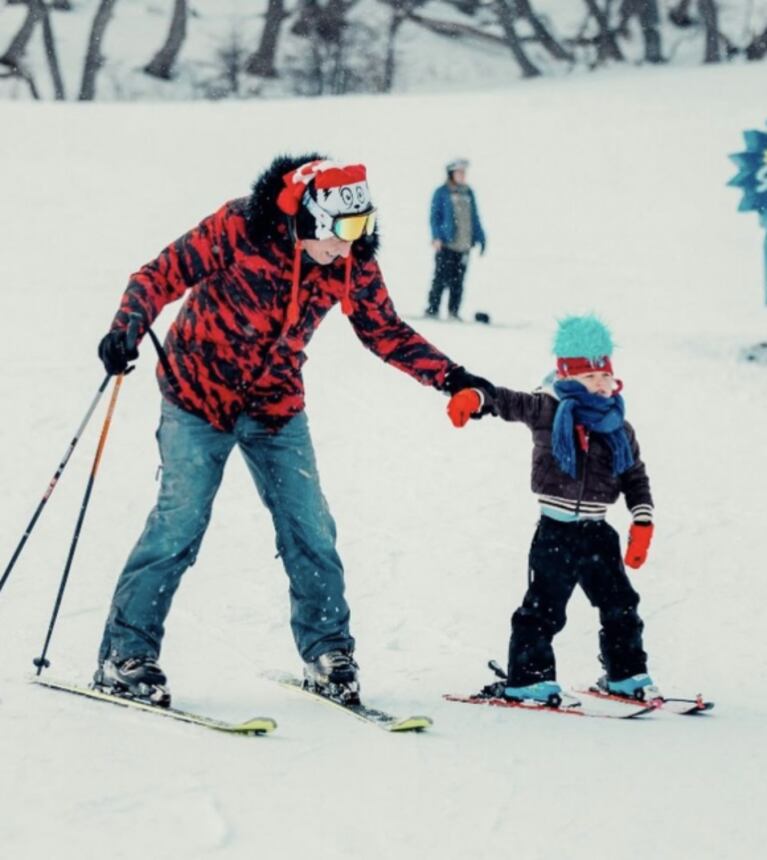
0,67,767,860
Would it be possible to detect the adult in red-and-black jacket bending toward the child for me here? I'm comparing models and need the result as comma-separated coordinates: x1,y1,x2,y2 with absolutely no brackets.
94,154,492,706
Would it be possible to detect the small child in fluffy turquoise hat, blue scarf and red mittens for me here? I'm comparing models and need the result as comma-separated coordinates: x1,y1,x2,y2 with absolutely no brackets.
448,315,660,706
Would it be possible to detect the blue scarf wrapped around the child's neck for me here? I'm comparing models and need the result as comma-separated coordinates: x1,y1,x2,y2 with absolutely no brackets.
551,379,634,478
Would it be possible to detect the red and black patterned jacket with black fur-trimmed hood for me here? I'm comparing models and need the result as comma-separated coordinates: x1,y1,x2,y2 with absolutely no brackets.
107,155,456,431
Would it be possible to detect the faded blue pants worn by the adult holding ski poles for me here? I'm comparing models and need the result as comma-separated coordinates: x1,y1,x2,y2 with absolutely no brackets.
99,400,354,662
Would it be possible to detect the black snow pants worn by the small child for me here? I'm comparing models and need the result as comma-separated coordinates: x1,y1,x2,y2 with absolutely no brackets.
508,516,647,687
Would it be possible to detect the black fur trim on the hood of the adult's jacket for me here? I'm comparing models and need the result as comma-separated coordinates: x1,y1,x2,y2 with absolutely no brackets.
245,152,378,262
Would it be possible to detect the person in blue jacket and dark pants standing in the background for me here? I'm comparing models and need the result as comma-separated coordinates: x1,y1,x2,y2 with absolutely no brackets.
426,158,487,320
